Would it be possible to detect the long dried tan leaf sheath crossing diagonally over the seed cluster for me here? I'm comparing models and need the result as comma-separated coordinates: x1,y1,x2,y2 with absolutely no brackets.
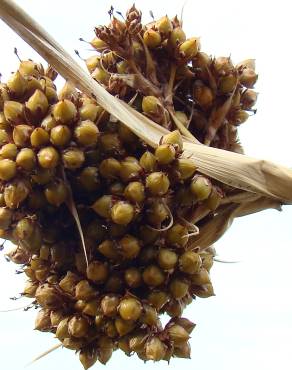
0,0,292,203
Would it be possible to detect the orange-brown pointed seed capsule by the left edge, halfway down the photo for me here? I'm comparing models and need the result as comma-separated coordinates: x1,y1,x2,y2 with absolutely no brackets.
4,180,31,209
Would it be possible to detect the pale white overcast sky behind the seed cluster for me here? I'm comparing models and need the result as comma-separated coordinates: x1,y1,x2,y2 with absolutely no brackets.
0,0,292,370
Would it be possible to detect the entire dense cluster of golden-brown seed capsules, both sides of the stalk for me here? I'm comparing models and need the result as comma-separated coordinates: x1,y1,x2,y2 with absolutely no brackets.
0,7,257,369
